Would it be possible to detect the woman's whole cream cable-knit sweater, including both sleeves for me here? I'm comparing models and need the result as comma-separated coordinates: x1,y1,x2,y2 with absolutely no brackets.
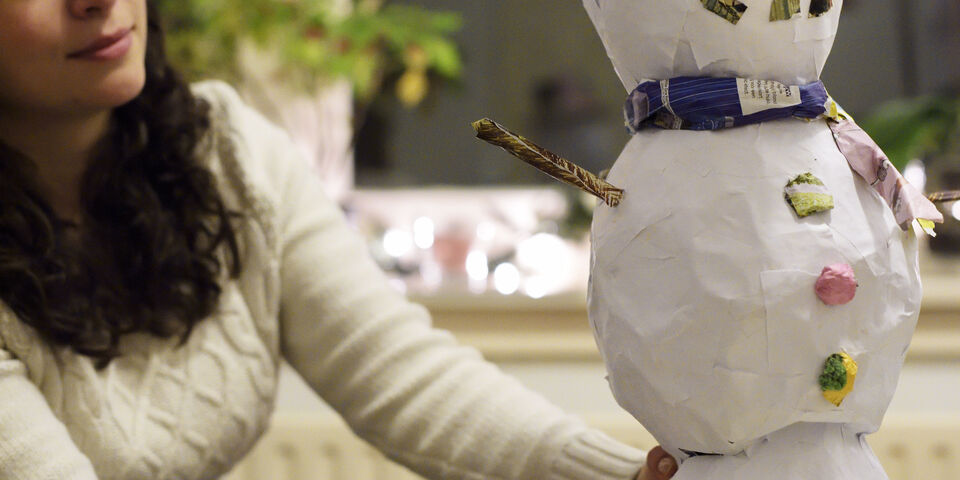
0,83,643,480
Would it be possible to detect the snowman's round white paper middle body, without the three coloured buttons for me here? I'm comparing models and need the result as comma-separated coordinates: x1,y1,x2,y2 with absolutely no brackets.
588,119,921,460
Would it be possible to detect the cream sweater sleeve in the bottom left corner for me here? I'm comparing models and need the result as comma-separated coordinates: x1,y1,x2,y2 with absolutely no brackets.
0,334,97,480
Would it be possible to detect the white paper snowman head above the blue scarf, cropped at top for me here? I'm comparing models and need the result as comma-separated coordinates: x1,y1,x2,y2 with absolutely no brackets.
583,0,843,91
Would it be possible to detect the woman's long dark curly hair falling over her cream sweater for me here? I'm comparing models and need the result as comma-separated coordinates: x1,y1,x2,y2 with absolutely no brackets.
0,1,241,367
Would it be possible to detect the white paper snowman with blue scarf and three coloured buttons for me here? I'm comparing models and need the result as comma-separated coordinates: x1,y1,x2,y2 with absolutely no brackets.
584,0,942,480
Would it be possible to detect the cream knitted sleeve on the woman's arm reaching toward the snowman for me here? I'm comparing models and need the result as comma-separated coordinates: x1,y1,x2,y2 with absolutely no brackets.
222,90,643,480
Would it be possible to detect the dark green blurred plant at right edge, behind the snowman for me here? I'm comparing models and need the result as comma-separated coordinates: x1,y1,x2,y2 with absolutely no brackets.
863,96,960,171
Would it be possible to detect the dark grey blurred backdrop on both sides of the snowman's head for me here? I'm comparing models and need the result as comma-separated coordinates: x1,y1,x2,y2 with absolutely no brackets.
357,0,960,186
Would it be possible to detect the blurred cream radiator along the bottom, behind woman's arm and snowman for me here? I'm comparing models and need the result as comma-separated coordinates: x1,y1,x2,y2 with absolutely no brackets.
224,414,960,480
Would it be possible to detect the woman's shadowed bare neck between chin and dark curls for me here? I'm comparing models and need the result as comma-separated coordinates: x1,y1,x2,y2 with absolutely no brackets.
0,110,111,224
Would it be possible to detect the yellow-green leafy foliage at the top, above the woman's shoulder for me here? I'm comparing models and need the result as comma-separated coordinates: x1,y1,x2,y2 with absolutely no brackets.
157,0,461,105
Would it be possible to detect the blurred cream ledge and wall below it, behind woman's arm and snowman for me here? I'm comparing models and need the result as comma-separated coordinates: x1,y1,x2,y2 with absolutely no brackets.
278,255,960,416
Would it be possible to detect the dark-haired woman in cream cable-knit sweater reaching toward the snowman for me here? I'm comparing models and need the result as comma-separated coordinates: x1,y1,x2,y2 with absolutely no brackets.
0,0,672,480
